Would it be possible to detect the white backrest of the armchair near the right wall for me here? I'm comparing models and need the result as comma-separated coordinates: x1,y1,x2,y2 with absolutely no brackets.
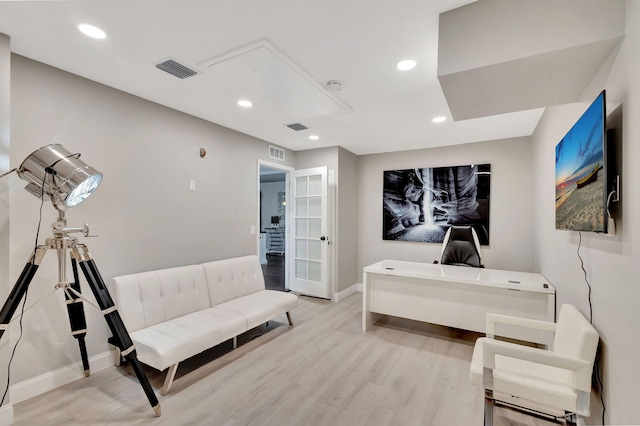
553,304,600,363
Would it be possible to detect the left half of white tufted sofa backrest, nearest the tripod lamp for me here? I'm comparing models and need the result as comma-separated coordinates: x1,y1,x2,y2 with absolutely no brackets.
107,265,209,332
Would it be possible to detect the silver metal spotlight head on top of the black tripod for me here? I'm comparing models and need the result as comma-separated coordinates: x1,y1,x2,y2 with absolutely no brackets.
18,144,102,210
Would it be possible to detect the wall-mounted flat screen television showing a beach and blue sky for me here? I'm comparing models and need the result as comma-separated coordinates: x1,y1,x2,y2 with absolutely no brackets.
556,91,608,233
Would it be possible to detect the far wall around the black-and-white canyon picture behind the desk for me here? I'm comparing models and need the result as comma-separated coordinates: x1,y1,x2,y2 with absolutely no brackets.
358,138,533,282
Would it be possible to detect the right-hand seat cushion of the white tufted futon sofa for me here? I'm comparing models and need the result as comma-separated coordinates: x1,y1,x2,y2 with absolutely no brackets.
216,290,298,329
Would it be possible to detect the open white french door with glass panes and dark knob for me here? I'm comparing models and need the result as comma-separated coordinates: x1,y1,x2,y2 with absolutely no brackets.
289,167,331,299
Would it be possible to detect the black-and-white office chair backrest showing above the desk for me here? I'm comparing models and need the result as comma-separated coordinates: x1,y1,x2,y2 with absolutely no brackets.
440,226,483,268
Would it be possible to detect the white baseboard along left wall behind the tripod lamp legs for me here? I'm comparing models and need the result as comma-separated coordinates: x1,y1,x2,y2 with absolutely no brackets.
9,351,114,406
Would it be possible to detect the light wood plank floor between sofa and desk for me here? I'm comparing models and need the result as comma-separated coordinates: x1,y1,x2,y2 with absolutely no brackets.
14,293,554,426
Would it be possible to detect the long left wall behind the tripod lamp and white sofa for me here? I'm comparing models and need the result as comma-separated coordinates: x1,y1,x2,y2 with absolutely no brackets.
7,55,295,383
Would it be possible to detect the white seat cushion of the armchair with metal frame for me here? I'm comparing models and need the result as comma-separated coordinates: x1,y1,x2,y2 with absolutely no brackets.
470,338,577,412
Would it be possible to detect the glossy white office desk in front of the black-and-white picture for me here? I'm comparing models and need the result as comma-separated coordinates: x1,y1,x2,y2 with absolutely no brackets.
362,260,556,343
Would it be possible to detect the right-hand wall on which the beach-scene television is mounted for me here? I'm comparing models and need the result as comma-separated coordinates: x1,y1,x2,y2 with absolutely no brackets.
533,1,640,424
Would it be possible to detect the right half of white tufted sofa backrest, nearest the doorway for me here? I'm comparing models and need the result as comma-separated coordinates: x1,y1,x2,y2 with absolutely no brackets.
202,256,265,306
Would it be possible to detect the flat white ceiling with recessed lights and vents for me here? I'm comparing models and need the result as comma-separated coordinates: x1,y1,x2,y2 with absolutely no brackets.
0,0,620,155
